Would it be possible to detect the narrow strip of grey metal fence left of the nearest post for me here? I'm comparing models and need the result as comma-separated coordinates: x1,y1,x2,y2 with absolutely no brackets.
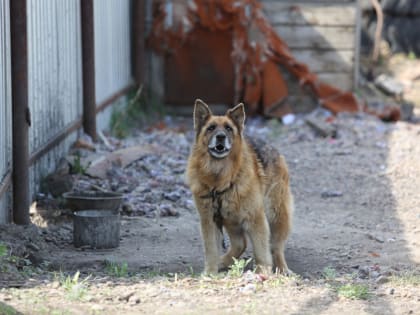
0,0,12,223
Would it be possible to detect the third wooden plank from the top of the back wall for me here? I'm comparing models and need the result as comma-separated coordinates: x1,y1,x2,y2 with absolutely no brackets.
292,49,354,75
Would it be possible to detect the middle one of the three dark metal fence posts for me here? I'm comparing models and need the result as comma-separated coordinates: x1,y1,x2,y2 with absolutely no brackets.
80,0,97,141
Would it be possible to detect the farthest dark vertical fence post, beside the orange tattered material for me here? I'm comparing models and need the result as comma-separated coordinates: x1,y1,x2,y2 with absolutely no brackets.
131,0,146,85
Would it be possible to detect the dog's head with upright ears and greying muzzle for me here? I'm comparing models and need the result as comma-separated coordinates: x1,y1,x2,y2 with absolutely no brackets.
194,99,245,159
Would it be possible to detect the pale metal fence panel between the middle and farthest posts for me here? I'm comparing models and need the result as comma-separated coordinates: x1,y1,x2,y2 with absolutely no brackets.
94,0,132,104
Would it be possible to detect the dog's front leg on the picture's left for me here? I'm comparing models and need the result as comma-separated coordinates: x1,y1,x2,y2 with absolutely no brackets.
200,211,220,274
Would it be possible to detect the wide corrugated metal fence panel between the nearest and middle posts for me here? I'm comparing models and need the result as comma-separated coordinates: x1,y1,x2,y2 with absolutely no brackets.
27,0,82,196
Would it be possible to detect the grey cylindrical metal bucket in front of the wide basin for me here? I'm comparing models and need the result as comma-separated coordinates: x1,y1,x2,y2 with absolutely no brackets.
73,210,120,249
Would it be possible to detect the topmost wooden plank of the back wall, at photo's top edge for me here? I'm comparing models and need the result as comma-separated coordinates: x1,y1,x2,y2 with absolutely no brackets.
264,1,356,26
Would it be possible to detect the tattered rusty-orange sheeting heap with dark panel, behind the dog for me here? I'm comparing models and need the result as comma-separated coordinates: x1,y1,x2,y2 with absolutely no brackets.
149,0,399,120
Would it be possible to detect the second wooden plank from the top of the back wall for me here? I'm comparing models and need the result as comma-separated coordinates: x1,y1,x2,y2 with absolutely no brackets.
274,25,355,50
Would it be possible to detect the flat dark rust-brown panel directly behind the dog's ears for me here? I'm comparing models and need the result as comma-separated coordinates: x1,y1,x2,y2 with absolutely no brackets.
165,28,235,106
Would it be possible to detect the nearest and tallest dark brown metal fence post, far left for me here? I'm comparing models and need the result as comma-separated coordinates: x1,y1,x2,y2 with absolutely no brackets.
10,0,30,224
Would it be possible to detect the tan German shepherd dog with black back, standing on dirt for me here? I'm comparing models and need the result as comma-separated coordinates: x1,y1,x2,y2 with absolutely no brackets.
186,99,293,274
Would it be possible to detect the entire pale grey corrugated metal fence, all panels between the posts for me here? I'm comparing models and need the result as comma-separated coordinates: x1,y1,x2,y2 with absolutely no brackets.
0,0,133,223
